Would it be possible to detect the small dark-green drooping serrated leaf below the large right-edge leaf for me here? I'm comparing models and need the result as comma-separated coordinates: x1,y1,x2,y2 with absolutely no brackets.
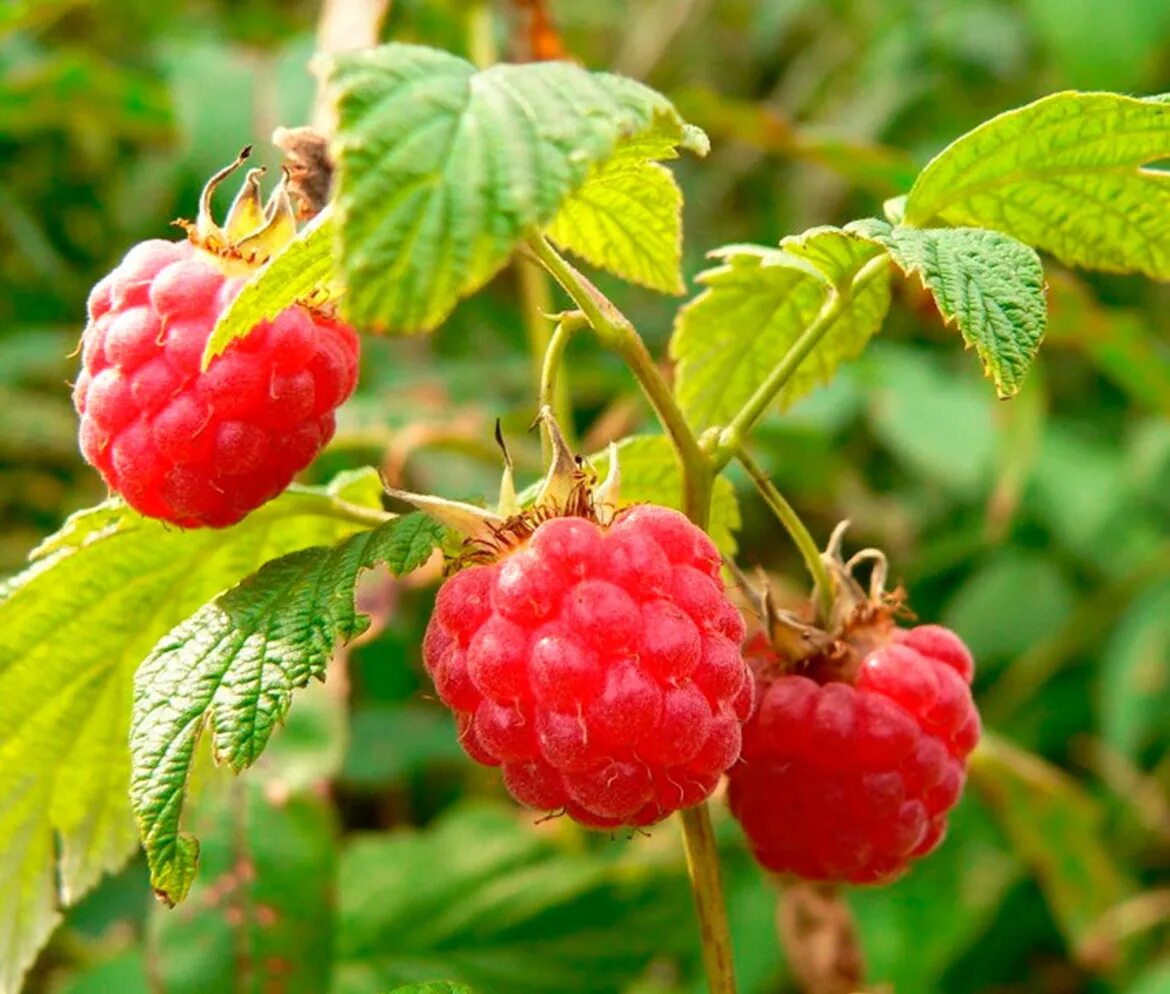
855,221,1047,398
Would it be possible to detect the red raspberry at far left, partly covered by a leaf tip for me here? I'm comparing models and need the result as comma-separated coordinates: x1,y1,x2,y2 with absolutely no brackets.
74,240,358,527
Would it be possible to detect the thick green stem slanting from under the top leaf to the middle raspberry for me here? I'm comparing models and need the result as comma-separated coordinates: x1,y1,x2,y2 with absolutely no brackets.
527,232,714,527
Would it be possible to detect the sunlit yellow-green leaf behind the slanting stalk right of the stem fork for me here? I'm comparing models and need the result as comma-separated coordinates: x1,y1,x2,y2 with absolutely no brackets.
670,228,889,430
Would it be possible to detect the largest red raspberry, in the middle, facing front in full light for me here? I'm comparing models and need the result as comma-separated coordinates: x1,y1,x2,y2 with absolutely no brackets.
422,504,753,828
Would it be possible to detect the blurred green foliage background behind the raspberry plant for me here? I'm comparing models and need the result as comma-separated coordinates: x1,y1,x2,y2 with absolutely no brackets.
0,0,1170,994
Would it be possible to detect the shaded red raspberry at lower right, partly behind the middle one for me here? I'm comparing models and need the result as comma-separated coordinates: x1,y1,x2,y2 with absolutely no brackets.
729,624,979,883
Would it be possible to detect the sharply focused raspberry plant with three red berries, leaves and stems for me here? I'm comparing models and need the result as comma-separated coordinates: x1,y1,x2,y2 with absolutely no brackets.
0,13,1170,994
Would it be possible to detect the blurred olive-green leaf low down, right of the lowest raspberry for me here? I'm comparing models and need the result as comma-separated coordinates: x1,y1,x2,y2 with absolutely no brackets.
970,734,1133,957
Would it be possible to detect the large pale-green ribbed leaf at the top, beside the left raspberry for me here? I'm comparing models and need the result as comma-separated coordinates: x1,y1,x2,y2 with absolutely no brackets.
329,44,702,332
